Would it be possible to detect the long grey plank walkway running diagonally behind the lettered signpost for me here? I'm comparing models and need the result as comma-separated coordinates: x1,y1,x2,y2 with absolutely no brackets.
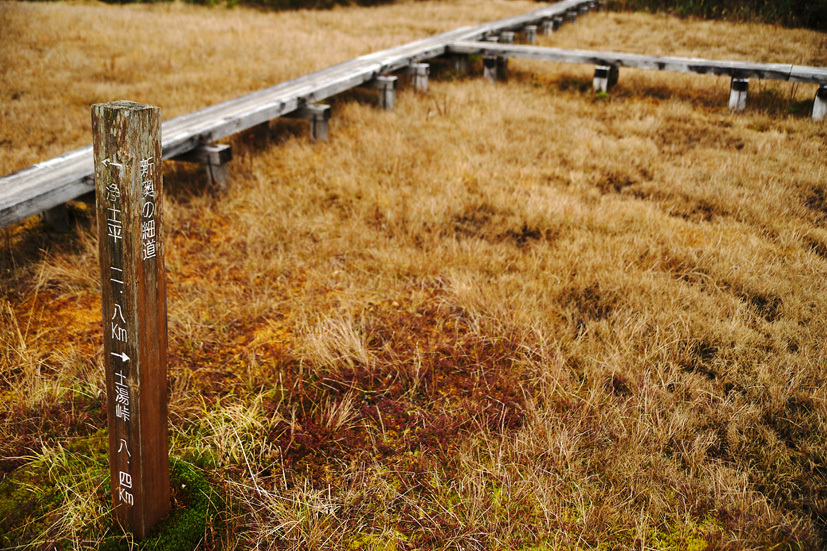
0,0,596,228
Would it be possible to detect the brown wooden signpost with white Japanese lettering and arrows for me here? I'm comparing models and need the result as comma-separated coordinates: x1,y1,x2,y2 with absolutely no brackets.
92,101,170,538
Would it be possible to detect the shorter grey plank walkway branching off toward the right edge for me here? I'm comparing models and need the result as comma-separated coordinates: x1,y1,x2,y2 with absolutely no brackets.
448,41,827,85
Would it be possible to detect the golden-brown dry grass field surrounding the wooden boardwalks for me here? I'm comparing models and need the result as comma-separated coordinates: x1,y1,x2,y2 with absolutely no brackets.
0,0,827,551
